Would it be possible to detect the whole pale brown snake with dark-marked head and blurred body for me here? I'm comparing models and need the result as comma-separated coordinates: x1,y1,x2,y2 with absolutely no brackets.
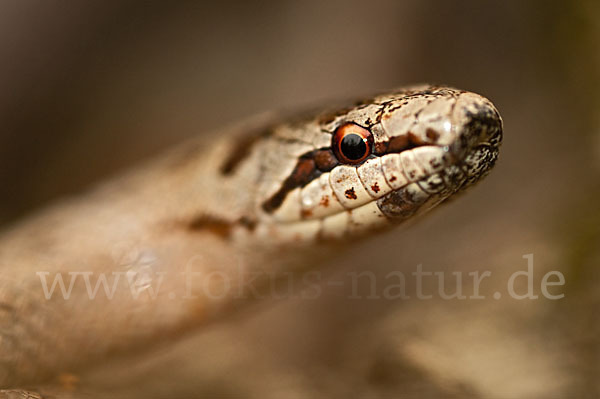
0,85,503,398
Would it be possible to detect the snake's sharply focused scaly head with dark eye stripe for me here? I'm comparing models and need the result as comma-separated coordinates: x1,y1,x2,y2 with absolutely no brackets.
250,86,502,241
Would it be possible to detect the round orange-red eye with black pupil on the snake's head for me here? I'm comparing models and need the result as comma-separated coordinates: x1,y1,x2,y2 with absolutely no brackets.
331,123,373,164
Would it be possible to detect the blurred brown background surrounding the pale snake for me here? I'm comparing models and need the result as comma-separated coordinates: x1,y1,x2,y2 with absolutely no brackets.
0,0,600,399
